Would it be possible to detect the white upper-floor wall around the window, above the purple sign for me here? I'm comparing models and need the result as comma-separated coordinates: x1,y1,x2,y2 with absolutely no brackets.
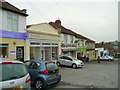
0,9,26,32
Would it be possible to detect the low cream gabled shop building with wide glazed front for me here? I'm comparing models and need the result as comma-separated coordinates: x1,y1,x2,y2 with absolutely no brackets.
26,23,60,60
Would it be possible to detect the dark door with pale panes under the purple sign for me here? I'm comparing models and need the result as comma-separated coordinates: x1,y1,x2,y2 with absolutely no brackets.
16,47,24,62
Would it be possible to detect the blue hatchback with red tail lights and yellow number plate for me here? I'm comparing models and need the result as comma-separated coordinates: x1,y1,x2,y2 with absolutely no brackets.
24,60,61,89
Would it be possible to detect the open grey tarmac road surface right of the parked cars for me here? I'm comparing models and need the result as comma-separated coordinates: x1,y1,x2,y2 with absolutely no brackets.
31,60,118,90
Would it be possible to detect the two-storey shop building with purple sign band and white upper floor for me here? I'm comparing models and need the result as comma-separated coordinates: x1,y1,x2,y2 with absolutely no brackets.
0,1,28,61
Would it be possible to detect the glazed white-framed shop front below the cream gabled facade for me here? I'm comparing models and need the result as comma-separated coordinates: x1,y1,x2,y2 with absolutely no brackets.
30,39,59,60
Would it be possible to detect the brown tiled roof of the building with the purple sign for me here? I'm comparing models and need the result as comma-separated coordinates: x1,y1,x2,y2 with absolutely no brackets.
0,0,28,16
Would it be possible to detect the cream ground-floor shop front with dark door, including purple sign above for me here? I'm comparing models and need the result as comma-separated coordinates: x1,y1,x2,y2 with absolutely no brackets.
0,30,28,61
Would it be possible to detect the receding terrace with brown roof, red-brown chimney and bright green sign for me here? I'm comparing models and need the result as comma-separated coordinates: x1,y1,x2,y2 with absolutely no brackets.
49,20,95,60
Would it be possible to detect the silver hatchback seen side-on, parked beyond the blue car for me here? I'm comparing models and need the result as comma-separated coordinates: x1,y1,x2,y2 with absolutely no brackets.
57,55,84,68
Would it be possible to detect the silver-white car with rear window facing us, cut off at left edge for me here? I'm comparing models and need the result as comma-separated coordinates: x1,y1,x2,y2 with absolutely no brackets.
0,58,31,90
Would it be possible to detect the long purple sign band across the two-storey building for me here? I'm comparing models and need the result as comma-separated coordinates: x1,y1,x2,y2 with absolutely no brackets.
0,30,28,39
